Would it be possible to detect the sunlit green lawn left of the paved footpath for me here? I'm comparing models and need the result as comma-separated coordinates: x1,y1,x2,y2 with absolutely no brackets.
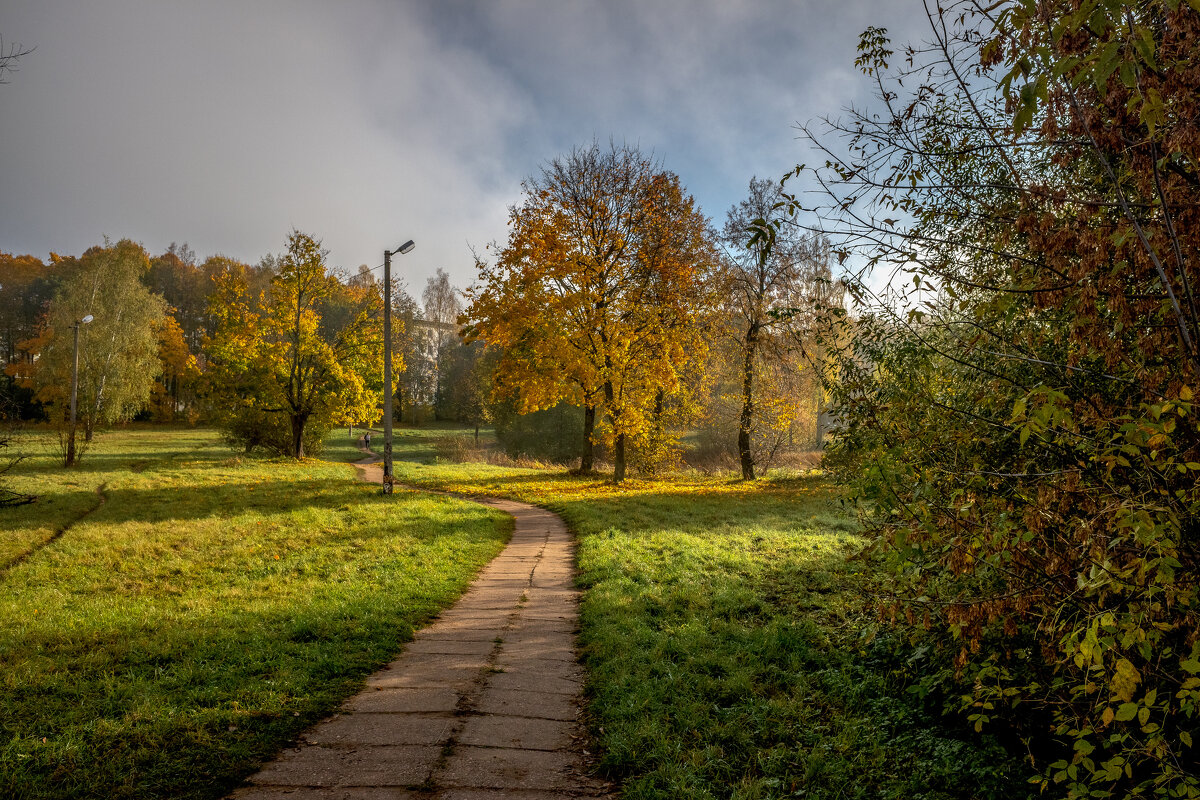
0,431,511,799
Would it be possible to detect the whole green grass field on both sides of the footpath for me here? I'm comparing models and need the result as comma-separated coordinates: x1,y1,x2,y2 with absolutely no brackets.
0,428,1028,800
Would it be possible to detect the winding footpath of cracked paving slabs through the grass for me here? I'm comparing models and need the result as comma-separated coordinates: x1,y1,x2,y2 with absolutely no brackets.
232,459,610,800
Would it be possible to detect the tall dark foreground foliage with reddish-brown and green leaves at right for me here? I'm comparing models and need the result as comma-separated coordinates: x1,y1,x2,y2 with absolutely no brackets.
764,0,1200,798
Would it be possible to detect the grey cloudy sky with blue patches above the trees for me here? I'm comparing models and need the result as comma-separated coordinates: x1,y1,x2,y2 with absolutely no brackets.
0,0,926,291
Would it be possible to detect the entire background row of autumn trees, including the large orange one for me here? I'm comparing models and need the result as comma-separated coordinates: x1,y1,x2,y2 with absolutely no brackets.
0,145,840,481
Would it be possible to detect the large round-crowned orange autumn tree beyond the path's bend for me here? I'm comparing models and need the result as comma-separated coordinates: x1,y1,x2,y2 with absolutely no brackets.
464,144,715,482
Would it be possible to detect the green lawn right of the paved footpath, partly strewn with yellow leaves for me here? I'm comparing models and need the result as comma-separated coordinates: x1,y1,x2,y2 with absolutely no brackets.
372,429,1028,800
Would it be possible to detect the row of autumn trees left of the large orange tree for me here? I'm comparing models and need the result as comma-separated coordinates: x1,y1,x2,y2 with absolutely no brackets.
0,231,492,464
